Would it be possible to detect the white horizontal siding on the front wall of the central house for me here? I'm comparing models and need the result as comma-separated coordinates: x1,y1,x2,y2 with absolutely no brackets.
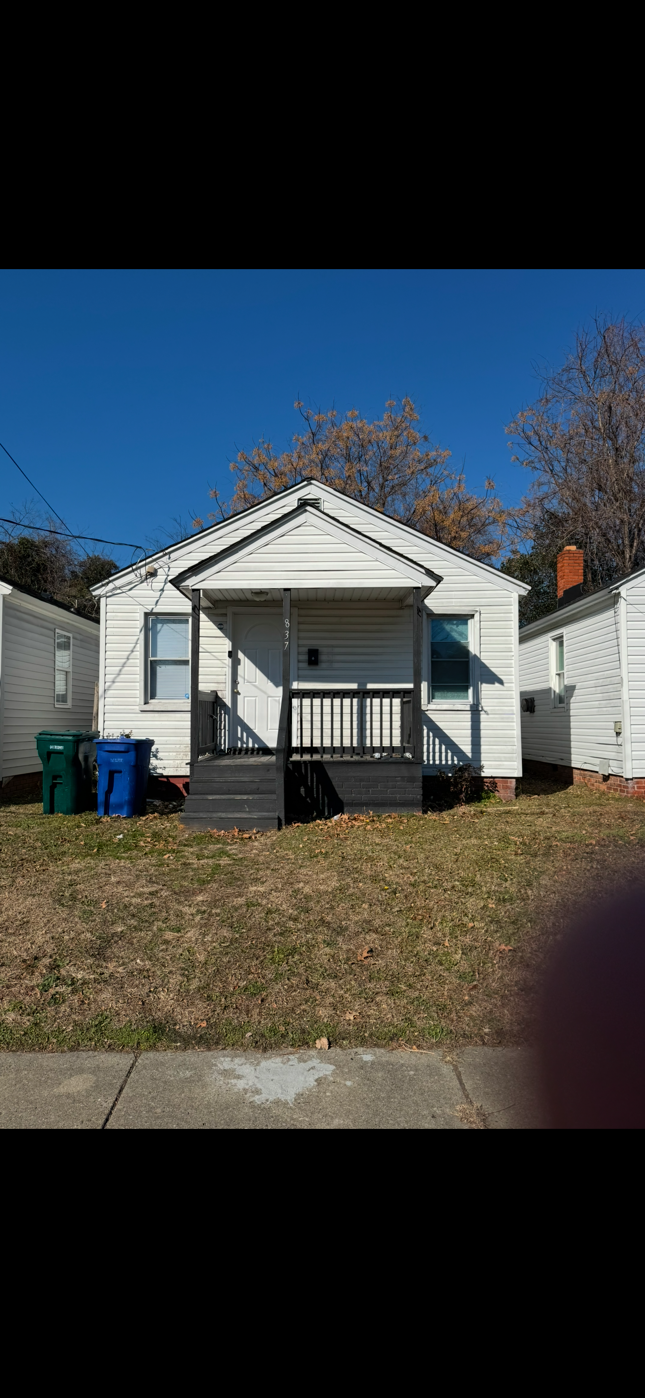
99,484,522,777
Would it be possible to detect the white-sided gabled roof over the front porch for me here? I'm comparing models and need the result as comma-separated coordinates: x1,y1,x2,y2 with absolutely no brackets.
173,505,441,603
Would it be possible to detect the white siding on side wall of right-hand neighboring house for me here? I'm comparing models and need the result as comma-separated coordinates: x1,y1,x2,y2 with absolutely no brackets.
519,596,624,776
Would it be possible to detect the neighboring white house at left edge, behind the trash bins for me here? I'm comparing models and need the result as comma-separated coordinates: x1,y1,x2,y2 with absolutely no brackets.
0,579,99,784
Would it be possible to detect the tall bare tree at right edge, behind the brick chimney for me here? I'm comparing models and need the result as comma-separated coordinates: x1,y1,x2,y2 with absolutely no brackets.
506,317,645,582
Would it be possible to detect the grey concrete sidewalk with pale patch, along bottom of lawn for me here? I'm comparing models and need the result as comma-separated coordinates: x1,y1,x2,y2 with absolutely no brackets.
0,1049,544,1131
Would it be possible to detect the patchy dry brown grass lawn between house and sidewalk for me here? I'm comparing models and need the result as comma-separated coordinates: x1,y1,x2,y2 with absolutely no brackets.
0,780,645,1049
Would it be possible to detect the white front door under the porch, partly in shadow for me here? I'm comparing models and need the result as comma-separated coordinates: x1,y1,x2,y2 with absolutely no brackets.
232,612,283,748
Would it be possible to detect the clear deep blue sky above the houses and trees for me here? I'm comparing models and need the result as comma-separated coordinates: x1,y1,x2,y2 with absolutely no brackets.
0,270,645,563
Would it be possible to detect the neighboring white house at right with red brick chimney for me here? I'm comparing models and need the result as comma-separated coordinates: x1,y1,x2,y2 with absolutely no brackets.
519,548,645,795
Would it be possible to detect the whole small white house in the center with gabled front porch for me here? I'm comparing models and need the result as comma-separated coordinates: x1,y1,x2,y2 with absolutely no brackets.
94,480,527,828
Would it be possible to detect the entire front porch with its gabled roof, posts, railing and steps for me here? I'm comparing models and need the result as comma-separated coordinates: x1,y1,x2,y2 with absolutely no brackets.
173,499,441,829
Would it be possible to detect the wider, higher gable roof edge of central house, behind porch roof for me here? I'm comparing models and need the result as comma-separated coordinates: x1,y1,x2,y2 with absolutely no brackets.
91,475,530,597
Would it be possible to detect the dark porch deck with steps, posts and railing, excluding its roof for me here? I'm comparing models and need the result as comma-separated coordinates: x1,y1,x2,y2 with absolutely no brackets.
183,589,423,829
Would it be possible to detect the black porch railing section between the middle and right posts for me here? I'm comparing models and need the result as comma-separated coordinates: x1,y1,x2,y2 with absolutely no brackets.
291,689,414,759
